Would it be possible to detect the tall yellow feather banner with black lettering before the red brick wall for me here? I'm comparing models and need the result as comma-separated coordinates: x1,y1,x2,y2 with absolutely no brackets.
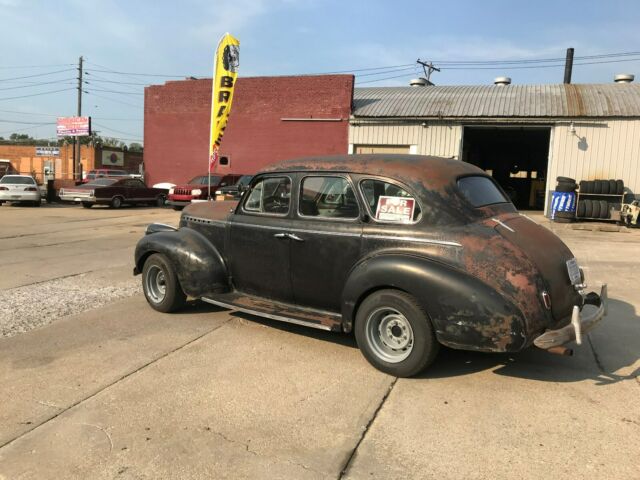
209,33,240,172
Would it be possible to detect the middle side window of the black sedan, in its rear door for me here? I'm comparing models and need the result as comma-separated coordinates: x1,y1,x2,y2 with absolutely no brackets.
298,177,359,218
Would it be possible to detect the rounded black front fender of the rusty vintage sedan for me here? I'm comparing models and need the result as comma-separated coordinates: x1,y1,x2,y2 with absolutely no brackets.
134,227,229,298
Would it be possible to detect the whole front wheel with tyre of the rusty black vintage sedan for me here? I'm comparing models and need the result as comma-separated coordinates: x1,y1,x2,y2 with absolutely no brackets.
142,253,187,313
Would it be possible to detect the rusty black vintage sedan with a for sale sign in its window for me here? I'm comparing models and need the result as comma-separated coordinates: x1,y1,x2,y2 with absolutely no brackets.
134,155,607,377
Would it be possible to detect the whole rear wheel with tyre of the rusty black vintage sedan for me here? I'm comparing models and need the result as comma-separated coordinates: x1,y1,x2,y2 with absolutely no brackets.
354,290,440,377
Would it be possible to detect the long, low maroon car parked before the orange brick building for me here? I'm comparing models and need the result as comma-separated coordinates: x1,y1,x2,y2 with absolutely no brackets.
58,178,166,208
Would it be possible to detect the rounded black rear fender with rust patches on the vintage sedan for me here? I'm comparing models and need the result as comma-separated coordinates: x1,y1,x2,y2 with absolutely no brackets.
342,254,527,352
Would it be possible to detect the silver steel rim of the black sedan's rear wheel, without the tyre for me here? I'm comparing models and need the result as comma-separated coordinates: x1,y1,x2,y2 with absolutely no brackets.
365,307,414,363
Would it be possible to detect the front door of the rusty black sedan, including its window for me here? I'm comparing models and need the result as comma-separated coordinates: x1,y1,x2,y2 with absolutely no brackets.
228,174,292,302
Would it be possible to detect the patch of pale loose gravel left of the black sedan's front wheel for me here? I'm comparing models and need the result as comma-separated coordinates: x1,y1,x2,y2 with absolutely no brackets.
0,273,142,337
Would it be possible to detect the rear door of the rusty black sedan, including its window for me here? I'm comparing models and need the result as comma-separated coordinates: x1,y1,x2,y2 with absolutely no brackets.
290,173,362,312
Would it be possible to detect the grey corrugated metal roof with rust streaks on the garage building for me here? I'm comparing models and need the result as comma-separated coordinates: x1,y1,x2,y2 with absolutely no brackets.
353,83,640,118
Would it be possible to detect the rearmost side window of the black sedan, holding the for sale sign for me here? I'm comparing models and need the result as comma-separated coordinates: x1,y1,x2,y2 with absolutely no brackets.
360,179,420,223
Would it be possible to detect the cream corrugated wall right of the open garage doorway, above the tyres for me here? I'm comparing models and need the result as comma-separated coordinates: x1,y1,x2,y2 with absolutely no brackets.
548,120,640,194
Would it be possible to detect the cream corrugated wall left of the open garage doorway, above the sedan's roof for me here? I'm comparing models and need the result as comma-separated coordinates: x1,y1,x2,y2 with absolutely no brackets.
349,122,462,158
